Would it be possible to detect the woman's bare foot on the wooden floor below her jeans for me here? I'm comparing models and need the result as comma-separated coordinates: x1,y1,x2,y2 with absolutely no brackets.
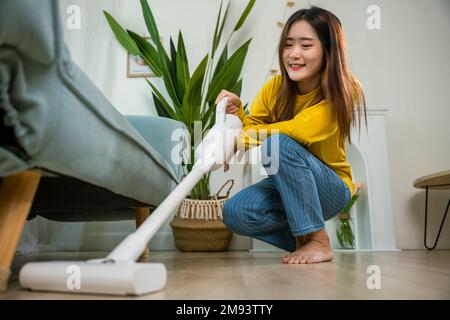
283,229,333,264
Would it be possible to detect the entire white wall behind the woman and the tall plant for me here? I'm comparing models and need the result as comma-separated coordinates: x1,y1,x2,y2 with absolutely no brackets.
62,0,450,248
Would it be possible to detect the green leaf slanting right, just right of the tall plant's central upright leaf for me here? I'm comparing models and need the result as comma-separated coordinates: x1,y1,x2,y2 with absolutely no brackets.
182,55,208,124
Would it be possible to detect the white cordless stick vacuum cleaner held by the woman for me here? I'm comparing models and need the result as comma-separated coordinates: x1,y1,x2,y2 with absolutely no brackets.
19,98,242,295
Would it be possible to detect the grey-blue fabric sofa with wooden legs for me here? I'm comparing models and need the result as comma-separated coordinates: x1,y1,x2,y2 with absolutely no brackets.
0,0,188,289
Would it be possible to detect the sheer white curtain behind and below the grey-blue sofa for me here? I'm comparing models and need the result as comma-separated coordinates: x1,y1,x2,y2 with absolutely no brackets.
17,0,118,254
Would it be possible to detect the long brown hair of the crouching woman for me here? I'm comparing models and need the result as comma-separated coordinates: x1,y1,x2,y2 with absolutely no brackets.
274,6,367,143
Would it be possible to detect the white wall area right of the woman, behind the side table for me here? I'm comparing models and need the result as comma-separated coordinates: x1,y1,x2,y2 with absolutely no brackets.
327,0,450,249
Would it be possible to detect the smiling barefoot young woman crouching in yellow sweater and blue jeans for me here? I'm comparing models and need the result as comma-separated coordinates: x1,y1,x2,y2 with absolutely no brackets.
217,7,367,263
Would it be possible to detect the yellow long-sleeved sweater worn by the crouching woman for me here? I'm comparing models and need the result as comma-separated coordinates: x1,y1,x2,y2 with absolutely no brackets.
238,76,356,195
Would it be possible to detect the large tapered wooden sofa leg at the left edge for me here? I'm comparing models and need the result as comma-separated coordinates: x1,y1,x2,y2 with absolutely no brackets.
0,170,41,292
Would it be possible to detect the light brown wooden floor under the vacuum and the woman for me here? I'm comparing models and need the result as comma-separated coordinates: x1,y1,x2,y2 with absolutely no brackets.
0,250,450,299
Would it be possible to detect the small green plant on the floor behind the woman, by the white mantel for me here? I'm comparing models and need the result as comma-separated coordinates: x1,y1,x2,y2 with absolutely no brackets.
336,182,363,249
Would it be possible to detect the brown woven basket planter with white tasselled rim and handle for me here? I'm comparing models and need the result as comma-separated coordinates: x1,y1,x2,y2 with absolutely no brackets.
170,180,234,252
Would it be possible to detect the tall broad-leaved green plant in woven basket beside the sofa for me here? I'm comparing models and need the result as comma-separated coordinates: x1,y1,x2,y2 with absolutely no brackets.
104,0,256,251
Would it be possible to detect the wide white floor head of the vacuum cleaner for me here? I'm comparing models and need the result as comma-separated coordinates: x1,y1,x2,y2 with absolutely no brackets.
19,261,167,295
